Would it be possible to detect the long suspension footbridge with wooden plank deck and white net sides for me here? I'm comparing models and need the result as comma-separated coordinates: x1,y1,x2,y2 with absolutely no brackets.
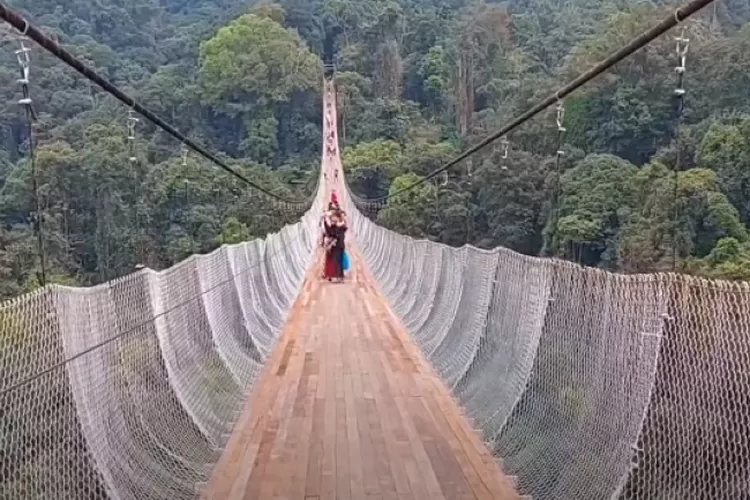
0,2,750,500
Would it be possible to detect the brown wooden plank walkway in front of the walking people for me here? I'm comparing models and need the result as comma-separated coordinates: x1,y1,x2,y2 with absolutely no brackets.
204,250,519,500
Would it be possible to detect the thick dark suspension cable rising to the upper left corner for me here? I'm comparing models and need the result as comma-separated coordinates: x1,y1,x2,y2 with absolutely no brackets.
0,1,307,205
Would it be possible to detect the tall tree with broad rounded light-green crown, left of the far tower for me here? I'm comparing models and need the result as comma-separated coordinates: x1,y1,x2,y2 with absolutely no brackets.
200,6,322,161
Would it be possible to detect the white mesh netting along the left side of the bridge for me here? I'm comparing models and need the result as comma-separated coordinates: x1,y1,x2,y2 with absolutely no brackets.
0,188,322,500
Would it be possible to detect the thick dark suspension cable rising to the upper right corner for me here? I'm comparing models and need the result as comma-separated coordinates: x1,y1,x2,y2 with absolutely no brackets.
360,0,714,202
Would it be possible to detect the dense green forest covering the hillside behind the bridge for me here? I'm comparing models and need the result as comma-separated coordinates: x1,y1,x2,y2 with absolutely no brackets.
0,0,750,297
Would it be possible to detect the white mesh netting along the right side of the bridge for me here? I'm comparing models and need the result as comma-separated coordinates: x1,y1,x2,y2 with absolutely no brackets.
348,189,750,500
